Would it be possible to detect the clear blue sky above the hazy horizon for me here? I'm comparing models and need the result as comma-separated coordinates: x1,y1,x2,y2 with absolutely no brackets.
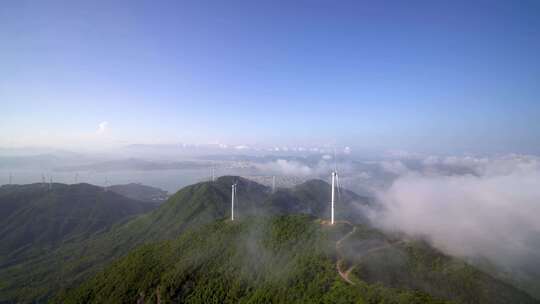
0,0,540,153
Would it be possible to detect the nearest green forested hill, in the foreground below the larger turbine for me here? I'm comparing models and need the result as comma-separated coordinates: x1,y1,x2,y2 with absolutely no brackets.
55,215,535,303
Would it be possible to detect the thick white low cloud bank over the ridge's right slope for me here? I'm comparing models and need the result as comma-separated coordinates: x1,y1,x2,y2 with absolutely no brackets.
373,155,540,275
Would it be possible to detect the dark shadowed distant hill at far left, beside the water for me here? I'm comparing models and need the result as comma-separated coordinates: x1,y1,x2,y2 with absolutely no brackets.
0,184,153,266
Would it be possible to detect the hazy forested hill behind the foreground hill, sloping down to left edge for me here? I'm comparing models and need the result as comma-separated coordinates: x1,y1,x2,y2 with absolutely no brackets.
0,176,269,302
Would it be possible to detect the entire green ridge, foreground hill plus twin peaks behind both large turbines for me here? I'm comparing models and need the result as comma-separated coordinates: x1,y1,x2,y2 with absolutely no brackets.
0,176,537,303
